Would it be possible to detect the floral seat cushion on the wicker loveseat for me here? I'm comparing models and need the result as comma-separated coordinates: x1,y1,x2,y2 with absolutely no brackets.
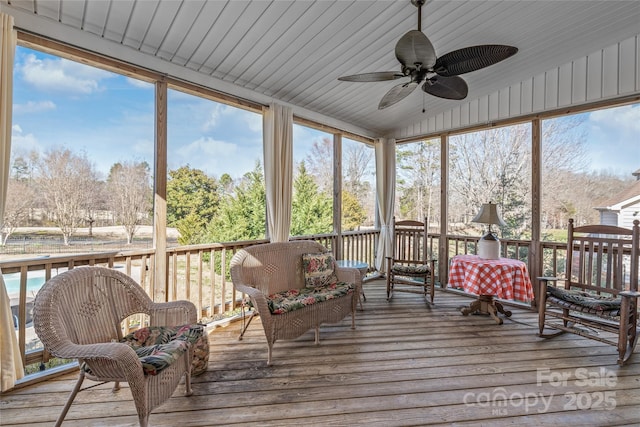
267,282,355,314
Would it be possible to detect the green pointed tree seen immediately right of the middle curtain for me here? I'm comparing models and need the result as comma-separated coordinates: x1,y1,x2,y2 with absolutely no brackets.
290,162,333,236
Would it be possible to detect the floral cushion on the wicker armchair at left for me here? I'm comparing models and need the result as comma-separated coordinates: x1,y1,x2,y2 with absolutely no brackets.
120,324,202,375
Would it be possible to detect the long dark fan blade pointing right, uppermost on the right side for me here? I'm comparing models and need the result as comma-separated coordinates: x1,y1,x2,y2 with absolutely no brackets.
433,44,518,77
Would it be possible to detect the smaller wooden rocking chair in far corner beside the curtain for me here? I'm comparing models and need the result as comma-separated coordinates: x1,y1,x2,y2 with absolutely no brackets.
387,218,436,304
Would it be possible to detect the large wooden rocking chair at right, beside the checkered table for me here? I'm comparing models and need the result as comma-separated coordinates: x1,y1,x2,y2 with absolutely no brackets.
537,219,640,366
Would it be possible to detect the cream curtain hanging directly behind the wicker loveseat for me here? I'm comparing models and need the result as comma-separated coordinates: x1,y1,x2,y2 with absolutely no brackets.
263,104,293,242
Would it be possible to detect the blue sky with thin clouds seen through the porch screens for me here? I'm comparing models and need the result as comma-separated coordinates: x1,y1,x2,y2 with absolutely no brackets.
12,47,640,178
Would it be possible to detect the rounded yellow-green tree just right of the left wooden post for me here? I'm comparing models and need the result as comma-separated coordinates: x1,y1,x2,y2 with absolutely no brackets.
167,165,220,245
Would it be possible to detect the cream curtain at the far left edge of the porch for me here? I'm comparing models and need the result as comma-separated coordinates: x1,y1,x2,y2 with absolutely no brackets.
0,12,24,391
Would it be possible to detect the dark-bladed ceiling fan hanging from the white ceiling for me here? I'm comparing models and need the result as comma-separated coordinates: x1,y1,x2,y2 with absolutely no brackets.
338,0,518,110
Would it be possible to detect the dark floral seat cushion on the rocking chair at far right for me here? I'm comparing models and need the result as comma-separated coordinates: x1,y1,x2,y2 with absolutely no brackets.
547,286,621,317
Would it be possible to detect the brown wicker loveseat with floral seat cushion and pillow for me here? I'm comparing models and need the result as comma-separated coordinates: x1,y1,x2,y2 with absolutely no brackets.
231,240,362,364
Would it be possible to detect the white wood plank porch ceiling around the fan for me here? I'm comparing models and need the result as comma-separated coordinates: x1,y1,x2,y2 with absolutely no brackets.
0,0,640,136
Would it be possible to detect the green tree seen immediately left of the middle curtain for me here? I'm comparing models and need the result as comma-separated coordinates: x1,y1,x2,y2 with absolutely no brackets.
203,163,267,243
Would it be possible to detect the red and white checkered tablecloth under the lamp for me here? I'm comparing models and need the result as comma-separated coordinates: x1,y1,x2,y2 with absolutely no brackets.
449,255,533,301
